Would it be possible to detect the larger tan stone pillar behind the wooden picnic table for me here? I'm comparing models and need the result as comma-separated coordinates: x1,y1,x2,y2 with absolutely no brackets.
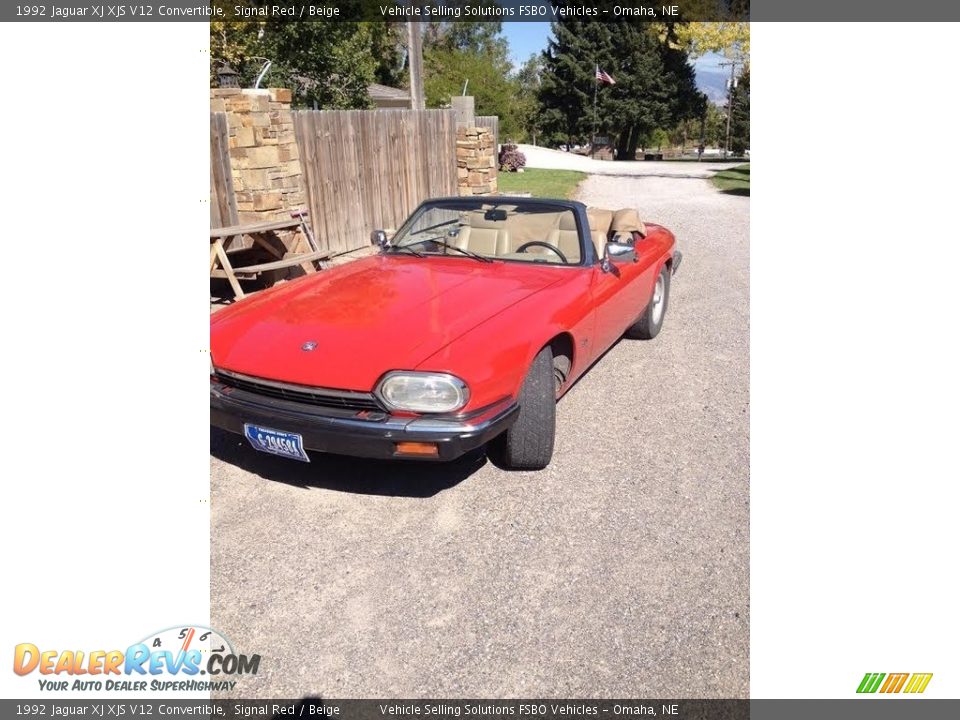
210,88,306,223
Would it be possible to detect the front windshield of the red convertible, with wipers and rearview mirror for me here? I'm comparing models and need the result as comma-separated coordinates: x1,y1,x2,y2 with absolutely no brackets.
390,198,581,265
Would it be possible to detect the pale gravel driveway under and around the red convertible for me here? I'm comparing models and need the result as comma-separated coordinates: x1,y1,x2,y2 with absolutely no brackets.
210,169,750,698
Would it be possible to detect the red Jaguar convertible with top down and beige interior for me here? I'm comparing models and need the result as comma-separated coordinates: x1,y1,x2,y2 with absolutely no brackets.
210,197,681,469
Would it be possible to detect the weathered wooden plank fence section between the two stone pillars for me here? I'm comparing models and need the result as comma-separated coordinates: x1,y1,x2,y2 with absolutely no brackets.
293,110,457,252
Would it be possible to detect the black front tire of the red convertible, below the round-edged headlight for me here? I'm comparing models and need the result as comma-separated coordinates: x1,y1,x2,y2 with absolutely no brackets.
488,347,557,470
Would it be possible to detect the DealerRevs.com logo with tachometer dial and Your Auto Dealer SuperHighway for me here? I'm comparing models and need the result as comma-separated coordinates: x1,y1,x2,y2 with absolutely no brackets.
13,625,260,692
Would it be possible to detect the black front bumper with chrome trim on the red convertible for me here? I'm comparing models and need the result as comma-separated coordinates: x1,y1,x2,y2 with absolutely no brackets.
210,378,520,461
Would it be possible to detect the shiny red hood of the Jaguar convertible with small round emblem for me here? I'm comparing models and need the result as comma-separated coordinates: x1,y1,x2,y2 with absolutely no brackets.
210,255,566,390
